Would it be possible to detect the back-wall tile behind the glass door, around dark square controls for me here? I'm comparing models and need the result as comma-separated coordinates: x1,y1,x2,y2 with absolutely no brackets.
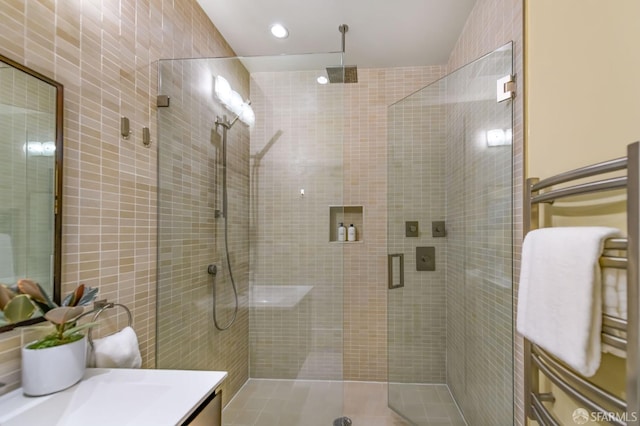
388,78,447,384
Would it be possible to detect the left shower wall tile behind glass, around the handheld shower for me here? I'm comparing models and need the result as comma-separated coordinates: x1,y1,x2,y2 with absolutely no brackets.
156,59,249,400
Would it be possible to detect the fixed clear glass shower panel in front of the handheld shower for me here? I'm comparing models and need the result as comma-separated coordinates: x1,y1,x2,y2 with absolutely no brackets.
156,54,344,424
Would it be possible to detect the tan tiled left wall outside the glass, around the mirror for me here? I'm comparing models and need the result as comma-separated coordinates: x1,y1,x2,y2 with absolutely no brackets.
0,0,247,393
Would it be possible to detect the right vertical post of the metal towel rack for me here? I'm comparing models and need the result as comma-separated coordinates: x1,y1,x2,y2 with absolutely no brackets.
627,142,640,426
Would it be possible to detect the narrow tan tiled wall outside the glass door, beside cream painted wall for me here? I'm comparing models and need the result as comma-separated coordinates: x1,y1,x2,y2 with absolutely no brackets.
448,0,524,425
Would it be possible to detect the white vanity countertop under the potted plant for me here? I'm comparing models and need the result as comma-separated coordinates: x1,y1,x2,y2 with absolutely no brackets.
0,368,227,426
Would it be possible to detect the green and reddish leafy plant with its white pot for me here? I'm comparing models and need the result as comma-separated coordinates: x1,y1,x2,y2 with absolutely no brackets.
0,280,98,396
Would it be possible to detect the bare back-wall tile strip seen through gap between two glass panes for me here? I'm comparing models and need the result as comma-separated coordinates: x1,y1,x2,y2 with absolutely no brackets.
345,66,445,381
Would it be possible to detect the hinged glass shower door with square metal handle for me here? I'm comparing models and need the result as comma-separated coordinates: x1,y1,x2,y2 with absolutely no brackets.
387,44,513,425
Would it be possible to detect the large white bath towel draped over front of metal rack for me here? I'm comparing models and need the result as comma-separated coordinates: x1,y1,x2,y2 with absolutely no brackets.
517,227,621,377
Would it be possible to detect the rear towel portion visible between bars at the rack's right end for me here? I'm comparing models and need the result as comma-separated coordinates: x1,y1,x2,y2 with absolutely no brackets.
602,268,627,358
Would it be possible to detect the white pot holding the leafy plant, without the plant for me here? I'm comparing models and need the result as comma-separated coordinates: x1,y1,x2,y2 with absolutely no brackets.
22,336,87,396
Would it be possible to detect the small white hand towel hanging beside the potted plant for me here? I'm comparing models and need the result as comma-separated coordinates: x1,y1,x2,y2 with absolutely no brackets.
89,327,142,368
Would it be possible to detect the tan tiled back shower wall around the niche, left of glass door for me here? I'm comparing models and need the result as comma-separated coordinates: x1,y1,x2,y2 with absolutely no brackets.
250,66,444,381
